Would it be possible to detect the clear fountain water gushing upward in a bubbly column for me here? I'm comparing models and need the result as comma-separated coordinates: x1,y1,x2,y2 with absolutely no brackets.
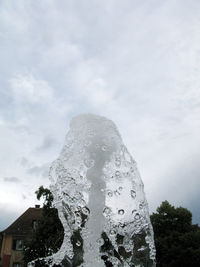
29,114,155,267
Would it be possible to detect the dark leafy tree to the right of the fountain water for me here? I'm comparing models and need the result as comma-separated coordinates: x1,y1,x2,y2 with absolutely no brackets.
151,201,200,267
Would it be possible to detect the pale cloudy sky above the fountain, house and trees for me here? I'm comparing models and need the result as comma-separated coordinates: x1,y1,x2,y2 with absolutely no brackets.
0,0,200,231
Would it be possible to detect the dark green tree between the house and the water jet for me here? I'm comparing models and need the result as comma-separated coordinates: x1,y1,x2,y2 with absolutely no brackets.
24,186,64,266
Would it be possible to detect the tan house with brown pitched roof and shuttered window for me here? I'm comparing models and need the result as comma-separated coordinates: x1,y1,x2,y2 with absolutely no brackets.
0,205,42,267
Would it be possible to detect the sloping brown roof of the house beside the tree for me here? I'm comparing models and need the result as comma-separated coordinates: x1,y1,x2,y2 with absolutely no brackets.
1,207,42,236
